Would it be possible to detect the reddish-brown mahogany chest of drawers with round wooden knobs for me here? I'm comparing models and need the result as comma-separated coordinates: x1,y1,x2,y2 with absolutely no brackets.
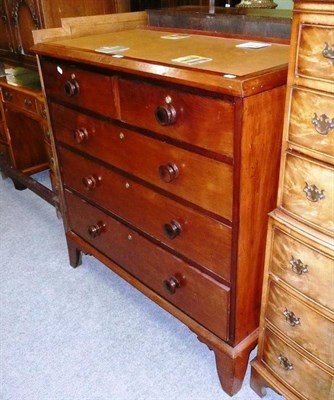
35,23,289,394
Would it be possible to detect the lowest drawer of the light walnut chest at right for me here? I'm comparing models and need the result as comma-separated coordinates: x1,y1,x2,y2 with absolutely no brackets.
262,329,334,400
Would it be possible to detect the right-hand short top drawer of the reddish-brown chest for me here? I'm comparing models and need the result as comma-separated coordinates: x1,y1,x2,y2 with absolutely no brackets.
119,79,234,157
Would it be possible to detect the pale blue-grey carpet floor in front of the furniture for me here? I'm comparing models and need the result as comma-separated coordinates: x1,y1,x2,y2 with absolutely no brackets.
0,173,281,400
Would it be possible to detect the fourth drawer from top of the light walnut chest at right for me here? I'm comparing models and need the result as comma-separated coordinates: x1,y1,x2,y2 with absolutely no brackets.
270,227,334,311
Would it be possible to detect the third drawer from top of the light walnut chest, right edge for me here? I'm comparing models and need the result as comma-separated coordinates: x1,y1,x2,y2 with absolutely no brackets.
282,153,334,235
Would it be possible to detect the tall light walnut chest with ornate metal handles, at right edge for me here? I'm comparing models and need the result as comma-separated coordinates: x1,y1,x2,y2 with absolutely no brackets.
251,1,334,400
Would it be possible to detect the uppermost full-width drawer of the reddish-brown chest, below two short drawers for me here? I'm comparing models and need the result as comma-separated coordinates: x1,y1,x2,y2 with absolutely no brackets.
51,104,233,220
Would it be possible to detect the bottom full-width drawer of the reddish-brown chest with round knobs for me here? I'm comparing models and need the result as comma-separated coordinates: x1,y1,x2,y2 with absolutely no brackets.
65,191,229,340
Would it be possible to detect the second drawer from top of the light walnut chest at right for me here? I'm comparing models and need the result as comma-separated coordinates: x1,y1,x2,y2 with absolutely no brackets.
289,88,334,163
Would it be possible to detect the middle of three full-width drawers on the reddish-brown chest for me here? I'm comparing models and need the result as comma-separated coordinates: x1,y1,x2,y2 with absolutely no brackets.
59,148,232,281
